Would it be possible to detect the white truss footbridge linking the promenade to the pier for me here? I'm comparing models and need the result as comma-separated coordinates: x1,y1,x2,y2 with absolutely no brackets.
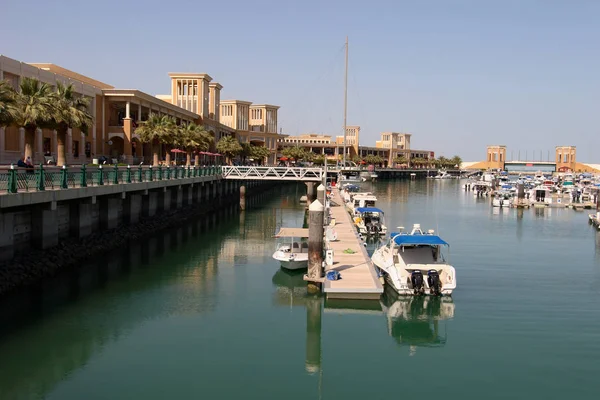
221,166,324,182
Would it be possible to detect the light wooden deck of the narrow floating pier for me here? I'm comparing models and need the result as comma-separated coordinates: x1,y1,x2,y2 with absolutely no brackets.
323,188,383,299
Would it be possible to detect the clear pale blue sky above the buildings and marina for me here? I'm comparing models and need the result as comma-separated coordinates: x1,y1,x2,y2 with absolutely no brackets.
0,0,600,163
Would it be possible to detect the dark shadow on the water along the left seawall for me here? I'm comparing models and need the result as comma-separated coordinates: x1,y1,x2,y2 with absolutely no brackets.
0,184,288,399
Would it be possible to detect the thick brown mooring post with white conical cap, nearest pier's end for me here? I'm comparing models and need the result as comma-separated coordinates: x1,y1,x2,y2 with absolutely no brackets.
308,200,324,292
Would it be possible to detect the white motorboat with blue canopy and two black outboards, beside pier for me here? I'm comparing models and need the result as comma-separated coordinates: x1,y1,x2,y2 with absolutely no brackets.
371,224,456,296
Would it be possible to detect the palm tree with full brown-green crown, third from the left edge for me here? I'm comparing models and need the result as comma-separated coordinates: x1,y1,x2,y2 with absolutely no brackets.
52,82,93,166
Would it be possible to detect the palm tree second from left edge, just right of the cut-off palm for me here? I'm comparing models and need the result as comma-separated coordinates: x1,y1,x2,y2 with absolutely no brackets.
15,78,55,161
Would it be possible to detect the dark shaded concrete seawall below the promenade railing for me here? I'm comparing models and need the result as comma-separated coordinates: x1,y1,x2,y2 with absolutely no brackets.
0,177,277,294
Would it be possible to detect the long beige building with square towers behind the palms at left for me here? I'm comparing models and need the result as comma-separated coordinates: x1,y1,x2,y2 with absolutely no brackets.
0,55,283,164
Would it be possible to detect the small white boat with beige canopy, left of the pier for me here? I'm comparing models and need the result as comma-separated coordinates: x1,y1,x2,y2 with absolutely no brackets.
273,228,308,270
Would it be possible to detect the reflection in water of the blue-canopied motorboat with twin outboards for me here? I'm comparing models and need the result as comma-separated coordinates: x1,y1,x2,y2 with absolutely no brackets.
381,290,454,356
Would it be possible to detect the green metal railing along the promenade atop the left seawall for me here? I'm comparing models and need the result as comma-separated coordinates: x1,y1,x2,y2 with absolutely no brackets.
0,164,222,194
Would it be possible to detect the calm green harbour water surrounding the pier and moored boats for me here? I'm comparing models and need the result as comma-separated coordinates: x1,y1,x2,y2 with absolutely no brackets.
0,181,600,399
